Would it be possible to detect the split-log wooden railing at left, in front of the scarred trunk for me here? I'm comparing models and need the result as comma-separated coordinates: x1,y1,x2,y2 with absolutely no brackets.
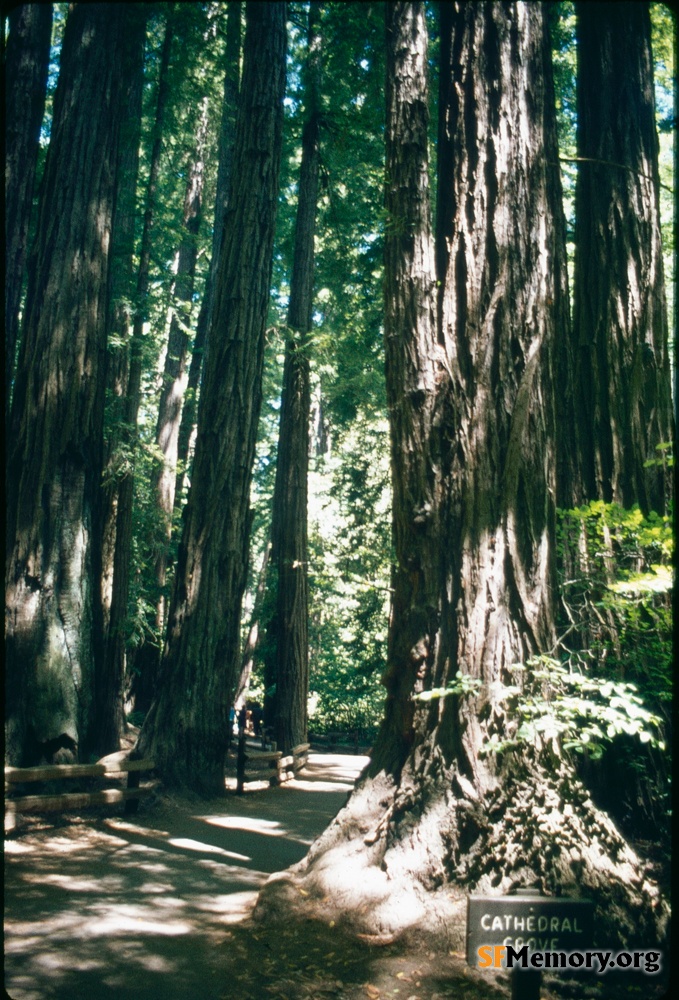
5,750,155,830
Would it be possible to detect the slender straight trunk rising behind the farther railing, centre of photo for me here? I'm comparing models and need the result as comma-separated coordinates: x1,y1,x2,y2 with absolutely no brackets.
269,2,321,751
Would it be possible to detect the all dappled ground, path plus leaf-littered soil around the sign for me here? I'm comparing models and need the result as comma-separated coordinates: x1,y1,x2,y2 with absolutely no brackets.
5,754,659,1000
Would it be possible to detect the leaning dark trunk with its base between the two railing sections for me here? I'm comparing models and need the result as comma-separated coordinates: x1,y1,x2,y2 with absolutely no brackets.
139,2,286,794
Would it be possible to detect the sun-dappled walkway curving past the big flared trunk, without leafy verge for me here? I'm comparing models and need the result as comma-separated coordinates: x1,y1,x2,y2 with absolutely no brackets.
5,754,367,1000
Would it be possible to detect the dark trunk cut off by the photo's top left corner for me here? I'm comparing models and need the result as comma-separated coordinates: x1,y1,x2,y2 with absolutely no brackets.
5,3,52,423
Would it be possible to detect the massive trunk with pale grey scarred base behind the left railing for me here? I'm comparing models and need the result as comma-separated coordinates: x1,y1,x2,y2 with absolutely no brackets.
6,4,126,764
